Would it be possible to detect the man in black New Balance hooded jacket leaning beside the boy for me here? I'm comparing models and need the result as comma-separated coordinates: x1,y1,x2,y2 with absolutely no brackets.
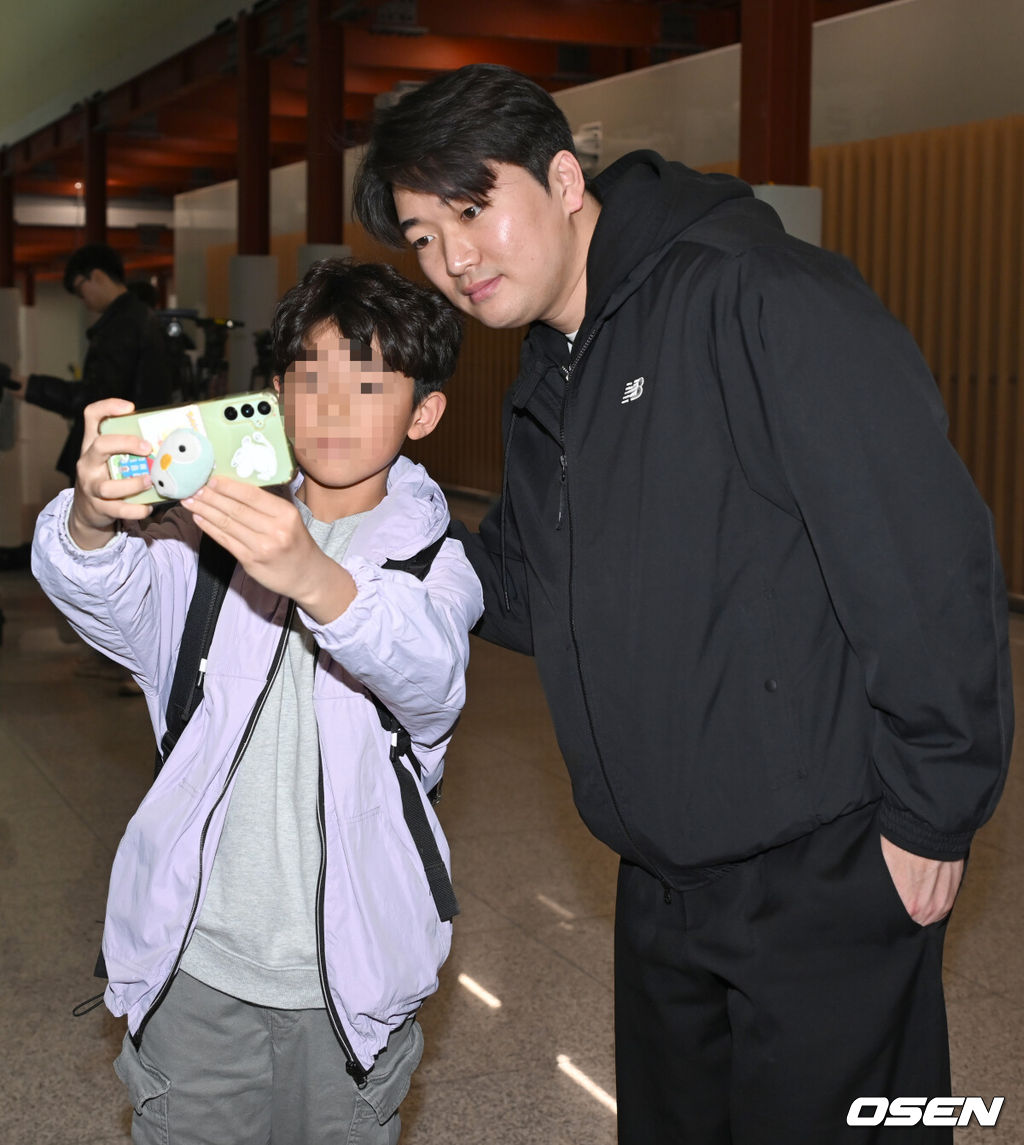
356,65,1013,1145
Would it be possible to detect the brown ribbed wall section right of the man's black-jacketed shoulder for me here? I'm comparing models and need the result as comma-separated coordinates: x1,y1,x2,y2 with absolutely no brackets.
811,116,1024,594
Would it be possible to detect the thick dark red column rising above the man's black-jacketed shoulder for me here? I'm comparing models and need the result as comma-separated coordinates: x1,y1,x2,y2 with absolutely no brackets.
740,0,814,187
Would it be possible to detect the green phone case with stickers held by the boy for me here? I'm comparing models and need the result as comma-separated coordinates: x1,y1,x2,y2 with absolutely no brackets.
100,389,296,505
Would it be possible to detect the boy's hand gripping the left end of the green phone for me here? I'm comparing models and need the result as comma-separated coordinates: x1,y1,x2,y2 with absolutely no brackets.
68,397,152,548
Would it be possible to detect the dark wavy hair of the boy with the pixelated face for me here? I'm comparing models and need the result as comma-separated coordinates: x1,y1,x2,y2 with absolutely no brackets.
270,259,463,405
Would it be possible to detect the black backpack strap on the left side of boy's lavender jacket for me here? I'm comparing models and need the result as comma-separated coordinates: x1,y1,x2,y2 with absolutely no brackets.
155,534,235,775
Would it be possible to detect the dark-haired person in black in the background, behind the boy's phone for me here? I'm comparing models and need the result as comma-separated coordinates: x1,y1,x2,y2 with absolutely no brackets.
16,243,171,481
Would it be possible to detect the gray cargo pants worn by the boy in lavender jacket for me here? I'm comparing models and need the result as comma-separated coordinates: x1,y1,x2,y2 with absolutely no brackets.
113,973,423,1145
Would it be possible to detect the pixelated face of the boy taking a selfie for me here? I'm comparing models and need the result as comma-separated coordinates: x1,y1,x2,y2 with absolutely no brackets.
279,323,443,503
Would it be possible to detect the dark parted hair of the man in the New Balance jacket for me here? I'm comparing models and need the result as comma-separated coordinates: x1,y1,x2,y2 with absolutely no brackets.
353,64,576,246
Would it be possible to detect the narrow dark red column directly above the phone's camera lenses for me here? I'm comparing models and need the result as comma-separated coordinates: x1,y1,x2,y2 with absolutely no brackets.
238,11,270,254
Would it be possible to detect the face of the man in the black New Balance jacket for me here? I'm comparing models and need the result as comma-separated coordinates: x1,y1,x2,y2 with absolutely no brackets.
394,160,585,333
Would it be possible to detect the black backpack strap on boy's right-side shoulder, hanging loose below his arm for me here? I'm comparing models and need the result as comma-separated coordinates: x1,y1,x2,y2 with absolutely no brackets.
375,535,459,923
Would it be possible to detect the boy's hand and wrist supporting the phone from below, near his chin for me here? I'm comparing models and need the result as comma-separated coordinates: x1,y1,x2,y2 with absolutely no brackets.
182,476,356,624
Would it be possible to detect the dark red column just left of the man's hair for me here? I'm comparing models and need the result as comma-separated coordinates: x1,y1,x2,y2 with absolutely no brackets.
306,0,345,244
